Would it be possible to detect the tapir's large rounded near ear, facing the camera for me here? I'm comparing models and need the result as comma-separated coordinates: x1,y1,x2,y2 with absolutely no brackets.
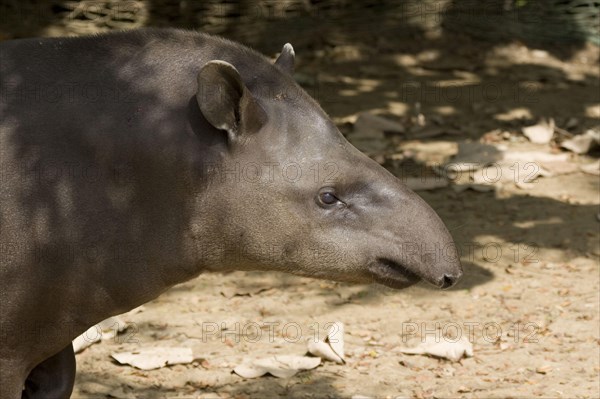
196,61,267,140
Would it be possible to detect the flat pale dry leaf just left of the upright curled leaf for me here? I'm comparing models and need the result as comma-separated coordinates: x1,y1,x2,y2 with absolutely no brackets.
233,355,321,378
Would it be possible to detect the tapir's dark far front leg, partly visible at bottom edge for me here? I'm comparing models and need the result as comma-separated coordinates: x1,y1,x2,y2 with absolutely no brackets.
22,344,75,399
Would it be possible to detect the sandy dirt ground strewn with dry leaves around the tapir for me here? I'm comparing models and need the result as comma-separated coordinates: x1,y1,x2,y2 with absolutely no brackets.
2,1,600,398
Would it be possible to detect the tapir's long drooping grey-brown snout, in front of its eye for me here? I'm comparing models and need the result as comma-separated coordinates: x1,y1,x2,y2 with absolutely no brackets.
336,163,463,289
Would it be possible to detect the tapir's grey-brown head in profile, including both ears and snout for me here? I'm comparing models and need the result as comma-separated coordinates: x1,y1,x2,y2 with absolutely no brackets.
197,44,462,288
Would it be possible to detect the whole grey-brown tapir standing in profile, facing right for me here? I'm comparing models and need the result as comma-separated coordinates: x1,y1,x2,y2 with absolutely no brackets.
0,29,462,398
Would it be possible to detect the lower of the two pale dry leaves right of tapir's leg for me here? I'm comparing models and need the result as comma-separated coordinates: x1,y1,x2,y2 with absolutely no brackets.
111,347,194,370
